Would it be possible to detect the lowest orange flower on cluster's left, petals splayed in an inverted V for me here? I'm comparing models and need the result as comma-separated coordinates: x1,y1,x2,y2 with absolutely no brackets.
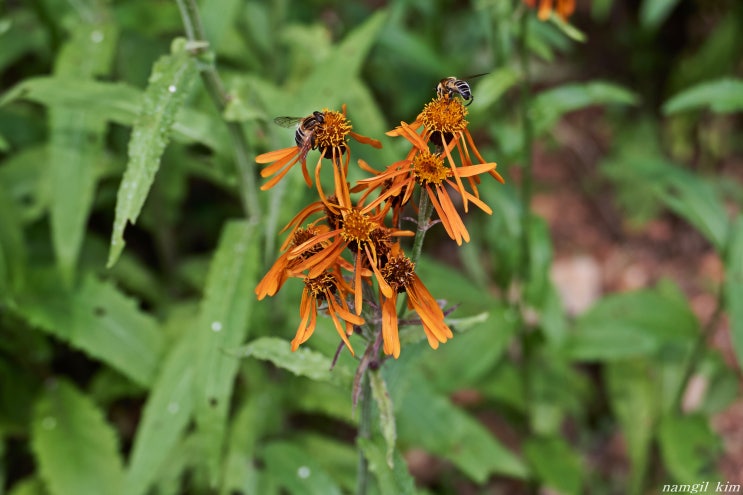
292,269,364,354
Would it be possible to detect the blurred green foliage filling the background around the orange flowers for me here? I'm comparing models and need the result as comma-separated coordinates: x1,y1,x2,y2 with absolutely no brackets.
0,0,743,495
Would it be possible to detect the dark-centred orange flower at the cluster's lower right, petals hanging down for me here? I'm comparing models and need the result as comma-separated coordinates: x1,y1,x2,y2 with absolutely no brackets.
380,244,454,359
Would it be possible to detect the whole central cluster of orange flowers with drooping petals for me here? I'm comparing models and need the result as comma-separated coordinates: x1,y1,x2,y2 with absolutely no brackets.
255,86,503,358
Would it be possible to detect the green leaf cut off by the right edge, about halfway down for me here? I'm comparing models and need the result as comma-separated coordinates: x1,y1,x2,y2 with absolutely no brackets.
723,214,743,364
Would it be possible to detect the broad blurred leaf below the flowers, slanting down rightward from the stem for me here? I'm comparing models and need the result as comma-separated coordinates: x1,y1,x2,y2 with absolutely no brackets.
392,372,527,483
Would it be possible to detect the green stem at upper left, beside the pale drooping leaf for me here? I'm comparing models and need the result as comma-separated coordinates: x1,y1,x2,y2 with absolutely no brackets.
176,0,260,221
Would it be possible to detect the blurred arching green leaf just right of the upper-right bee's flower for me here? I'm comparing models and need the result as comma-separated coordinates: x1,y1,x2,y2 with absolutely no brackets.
531,81,638,132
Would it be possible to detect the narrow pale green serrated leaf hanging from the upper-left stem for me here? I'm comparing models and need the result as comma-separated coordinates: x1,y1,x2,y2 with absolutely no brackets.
107,39,197,267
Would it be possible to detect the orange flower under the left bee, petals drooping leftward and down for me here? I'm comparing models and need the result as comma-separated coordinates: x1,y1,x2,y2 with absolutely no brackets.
255,104,382,209
